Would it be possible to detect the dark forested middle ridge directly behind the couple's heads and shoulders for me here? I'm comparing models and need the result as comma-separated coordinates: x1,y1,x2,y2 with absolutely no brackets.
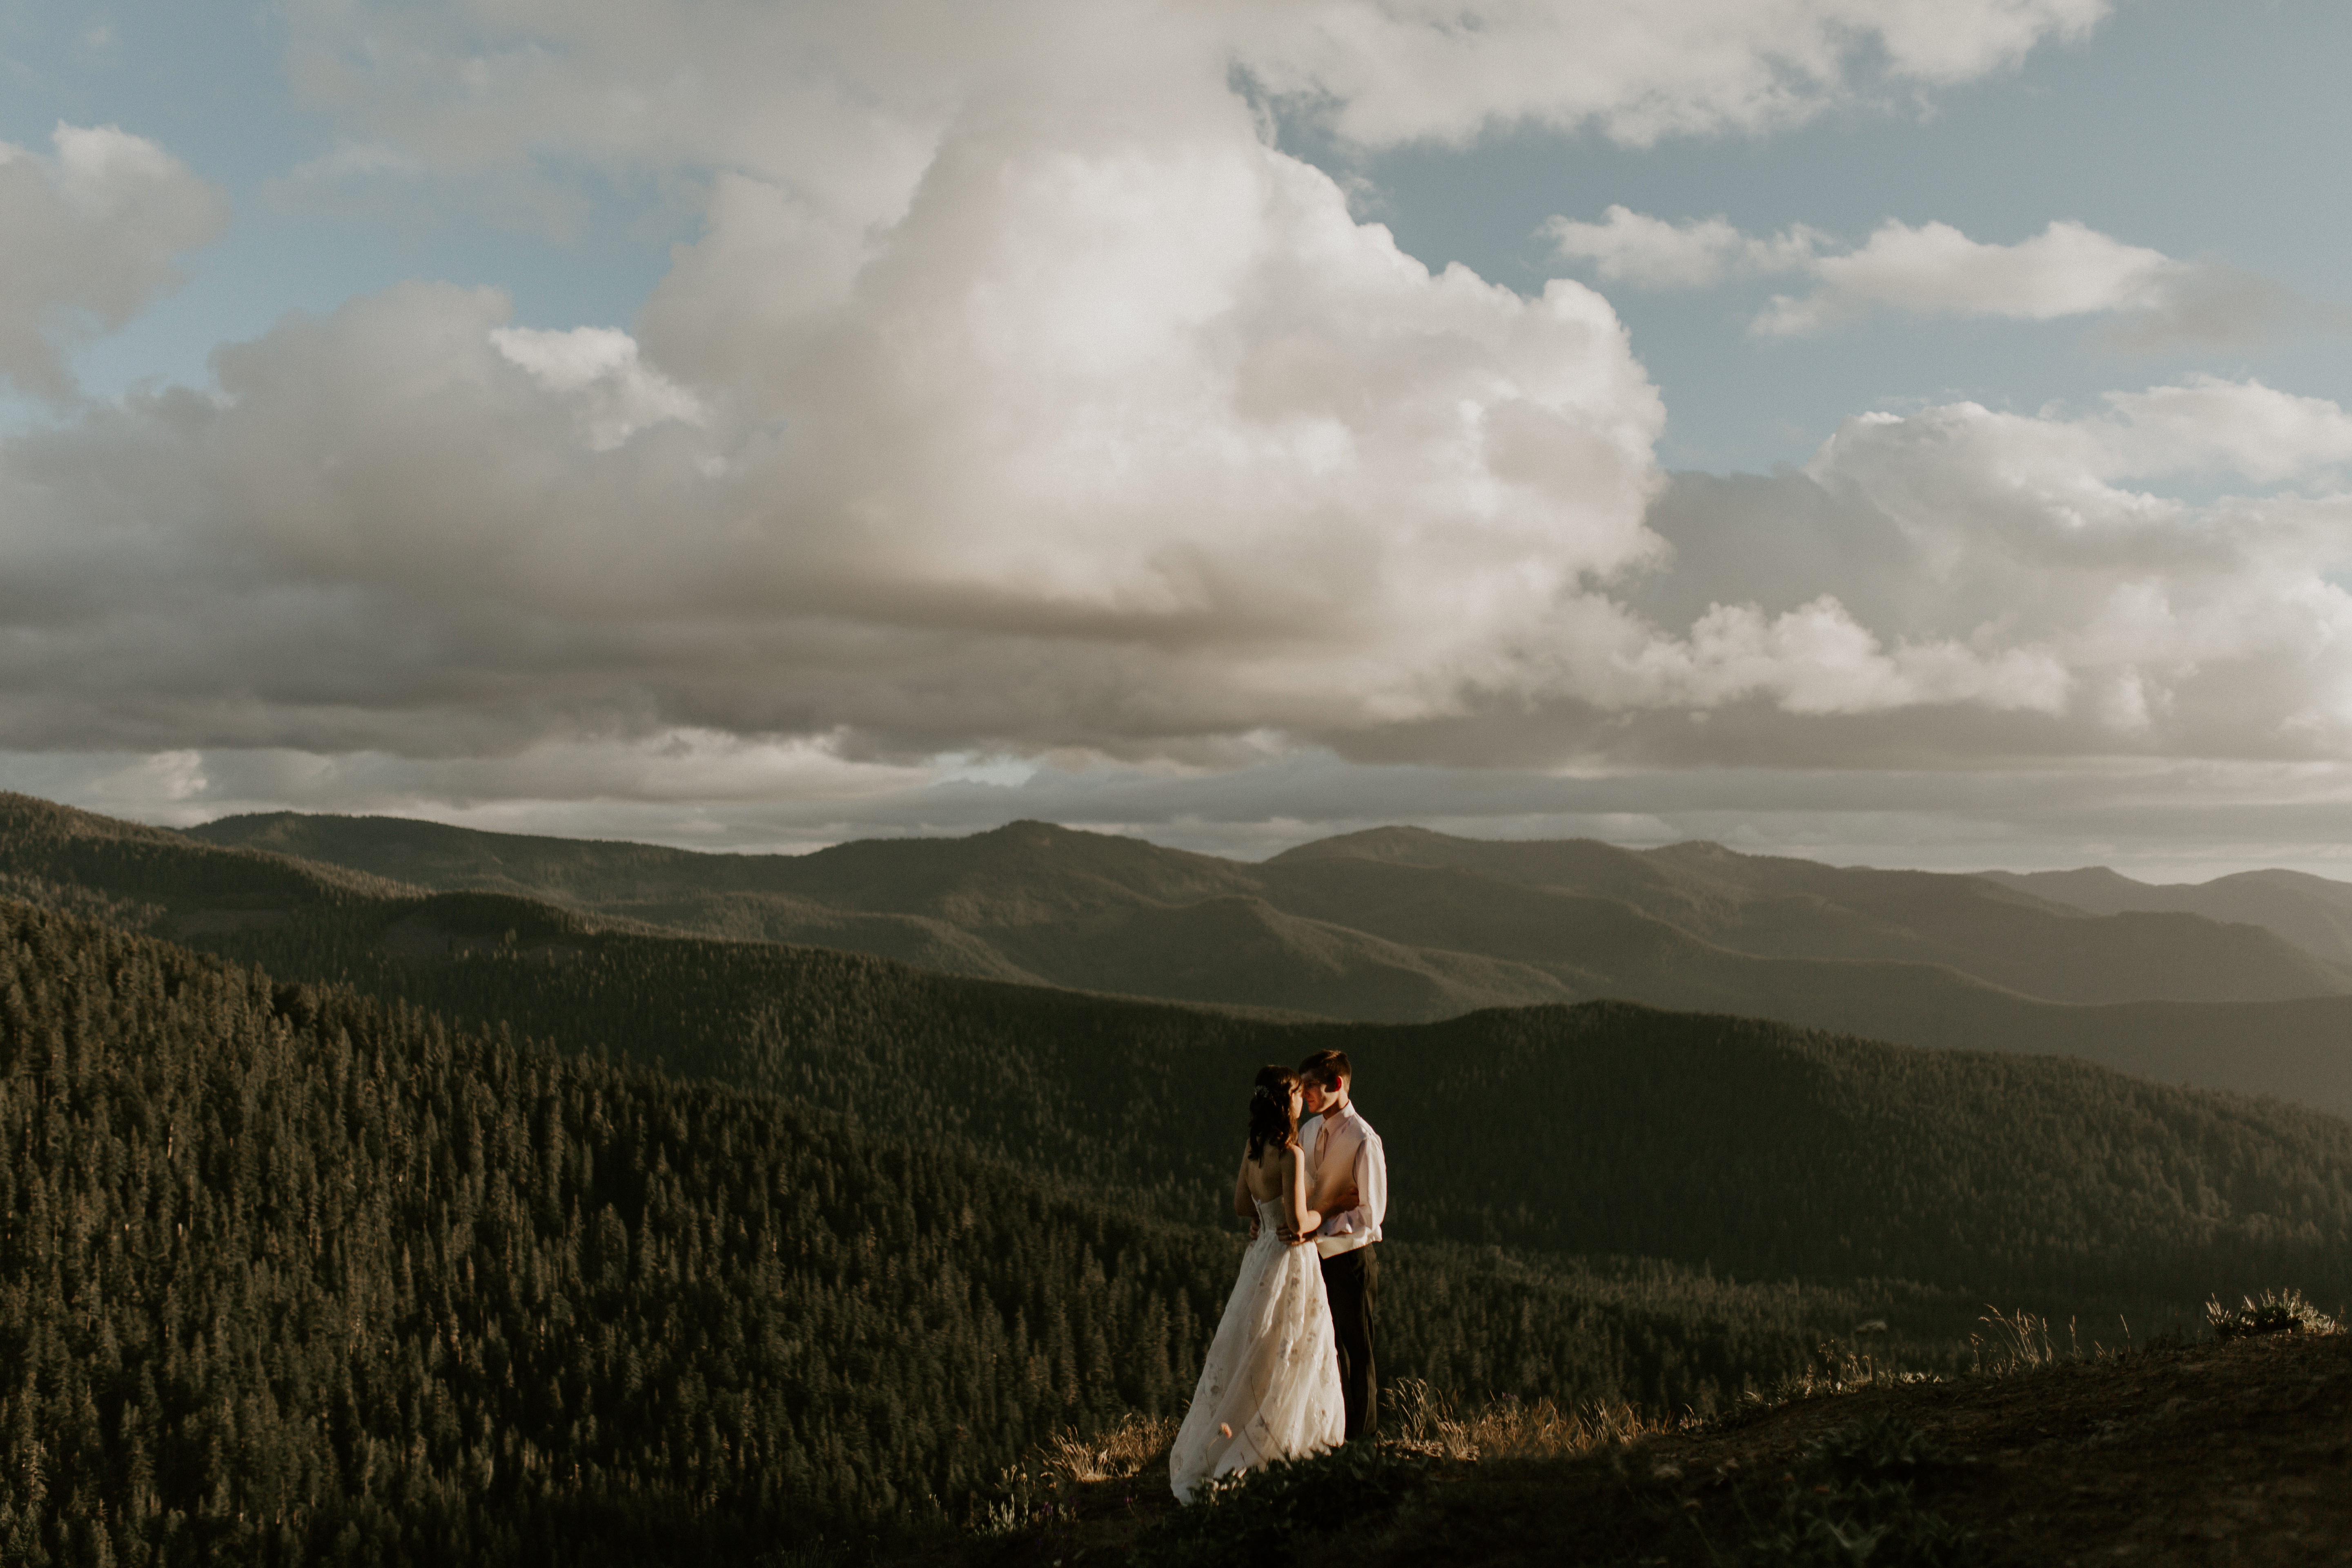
161,893,2352,1310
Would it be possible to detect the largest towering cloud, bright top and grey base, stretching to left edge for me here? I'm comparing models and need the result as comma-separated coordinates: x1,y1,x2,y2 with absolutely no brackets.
0,201,1661,750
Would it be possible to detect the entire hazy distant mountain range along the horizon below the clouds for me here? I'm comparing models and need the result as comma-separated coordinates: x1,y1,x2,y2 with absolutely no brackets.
0,797,2352,1114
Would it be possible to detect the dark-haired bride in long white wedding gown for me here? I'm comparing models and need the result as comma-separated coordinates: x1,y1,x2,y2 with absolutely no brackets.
1169,1067,1348,1502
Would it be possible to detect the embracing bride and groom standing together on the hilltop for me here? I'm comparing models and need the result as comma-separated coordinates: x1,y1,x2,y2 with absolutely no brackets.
1169,1051,1388,1500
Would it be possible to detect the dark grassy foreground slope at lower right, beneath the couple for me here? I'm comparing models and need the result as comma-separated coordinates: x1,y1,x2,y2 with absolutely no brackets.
964,1333,2352,1568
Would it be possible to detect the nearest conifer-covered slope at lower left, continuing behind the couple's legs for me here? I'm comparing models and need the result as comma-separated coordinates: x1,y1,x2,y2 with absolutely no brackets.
0,900,1907,1566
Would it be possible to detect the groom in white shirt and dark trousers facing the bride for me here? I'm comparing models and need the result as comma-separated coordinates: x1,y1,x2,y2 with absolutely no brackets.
1298,1051,1388,1441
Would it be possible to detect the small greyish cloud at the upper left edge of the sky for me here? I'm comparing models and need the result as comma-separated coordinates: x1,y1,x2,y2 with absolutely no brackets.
0,125,228,397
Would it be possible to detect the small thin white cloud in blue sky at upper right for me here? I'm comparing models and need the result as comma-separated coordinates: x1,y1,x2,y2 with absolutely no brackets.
1545,207,2305,348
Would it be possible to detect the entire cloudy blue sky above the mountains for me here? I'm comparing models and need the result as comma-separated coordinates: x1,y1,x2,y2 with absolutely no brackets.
0,0,2352,879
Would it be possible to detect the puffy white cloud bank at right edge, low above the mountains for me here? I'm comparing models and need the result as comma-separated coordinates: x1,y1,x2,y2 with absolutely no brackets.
1630,379,2352,760
